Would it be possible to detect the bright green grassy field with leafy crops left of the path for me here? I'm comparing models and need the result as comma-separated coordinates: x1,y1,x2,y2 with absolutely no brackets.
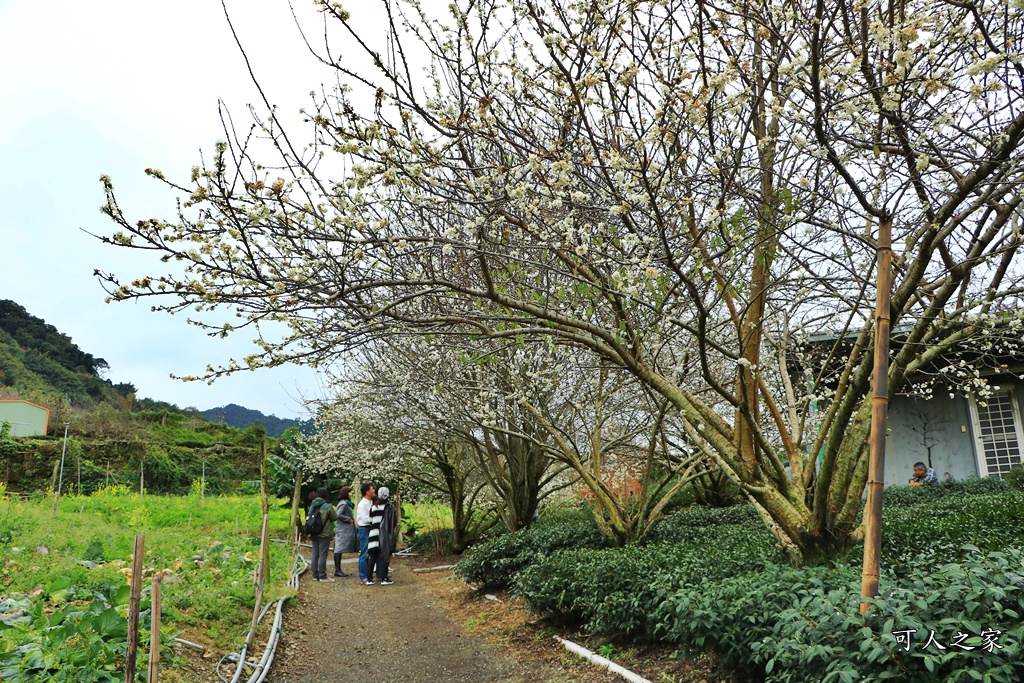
0,487,292,681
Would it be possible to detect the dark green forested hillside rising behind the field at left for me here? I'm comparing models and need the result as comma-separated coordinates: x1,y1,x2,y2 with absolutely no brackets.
0,300,297,494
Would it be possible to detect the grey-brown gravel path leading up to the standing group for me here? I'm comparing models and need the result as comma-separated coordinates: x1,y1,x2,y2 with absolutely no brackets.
268,558,526,683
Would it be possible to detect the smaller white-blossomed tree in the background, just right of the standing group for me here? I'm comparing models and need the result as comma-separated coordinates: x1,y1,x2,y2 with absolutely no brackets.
321,338,570,537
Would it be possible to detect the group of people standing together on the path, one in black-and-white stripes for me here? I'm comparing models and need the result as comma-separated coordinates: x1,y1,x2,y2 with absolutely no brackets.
309,483,398,586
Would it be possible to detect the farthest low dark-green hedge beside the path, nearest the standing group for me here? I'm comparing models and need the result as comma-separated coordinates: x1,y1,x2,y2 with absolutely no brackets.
456,510,604,587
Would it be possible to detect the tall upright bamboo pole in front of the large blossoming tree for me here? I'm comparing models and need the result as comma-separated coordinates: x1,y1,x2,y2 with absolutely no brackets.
860,217,893,614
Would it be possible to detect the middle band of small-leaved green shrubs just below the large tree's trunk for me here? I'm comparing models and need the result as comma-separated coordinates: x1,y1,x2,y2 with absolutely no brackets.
513,524,782,637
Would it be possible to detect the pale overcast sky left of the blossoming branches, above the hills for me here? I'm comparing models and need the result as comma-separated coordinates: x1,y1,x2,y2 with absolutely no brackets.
0,0,419,417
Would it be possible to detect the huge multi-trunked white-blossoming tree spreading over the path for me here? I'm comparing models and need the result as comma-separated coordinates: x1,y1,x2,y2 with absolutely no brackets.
100,0,1024,562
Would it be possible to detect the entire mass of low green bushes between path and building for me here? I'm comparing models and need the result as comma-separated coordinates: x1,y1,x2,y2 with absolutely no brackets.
459,479,1024,683
